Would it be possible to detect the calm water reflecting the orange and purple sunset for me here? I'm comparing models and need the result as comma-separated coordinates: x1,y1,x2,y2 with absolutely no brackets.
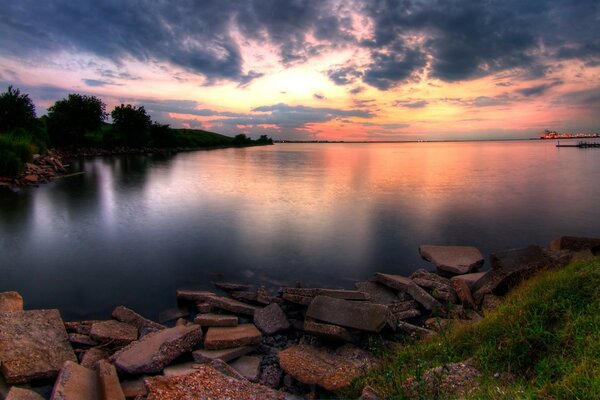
0,141,600,319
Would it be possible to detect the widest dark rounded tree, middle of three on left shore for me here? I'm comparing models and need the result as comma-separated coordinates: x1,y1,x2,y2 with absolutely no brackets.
47,93,108,146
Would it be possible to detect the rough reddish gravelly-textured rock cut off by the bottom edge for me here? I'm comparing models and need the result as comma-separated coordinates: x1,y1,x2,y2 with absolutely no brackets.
145,364,285,400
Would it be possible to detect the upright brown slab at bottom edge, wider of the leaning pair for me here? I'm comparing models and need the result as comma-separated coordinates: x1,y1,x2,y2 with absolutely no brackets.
50,361,100,400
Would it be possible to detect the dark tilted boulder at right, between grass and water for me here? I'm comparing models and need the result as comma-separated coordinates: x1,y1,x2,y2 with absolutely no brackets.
471,246,554,304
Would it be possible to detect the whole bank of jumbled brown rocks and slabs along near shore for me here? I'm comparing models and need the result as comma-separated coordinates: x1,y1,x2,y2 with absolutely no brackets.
0,237,600,400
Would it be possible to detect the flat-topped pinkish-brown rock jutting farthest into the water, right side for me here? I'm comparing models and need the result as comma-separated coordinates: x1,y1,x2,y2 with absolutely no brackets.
419,245,484,275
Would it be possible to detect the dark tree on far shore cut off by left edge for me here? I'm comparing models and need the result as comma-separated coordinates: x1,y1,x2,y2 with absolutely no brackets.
0,86,36,133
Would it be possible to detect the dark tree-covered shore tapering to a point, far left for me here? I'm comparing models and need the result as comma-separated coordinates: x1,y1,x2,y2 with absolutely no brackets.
0,86,273,177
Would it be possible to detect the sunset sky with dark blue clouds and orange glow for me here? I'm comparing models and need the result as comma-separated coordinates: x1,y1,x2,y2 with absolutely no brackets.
0,0,600,141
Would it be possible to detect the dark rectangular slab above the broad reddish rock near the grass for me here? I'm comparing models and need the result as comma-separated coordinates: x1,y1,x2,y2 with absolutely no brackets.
306,296,387,332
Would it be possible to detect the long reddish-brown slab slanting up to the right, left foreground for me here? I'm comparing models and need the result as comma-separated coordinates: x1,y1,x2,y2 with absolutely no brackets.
111,325,202,375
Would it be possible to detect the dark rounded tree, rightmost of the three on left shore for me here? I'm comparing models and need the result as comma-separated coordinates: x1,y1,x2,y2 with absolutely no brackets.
110,104,152,146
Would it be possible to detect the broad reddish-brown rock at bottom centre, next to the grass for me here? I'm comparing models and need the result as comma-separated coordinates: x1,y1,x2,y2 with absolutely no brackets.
278,344,375,391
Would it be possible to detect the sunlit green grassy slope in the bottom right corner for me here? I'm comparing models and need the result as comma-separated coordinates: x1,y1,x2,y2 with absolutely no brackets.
341,258,600,399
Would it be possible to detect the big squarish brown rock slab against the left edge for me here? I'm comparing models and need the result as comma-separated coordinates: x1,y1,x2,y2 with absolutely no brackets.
0,310,77,384
